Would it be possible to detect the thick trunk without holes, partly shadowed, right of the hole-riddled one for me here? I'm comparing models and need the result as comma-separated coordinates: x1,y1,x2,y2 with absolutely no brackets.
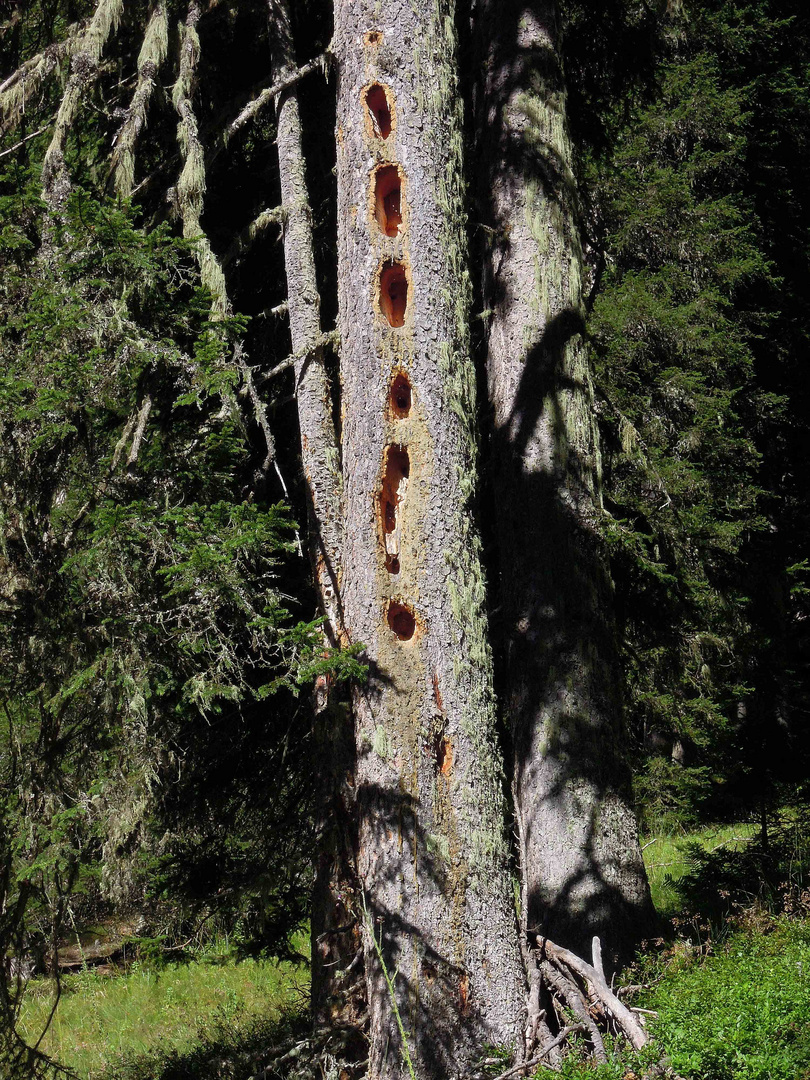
476,0,650,959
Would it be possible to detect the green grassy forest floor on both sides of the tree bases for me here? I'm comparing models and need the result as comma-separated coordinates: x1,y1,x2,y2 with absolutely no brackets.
17,825,810,1080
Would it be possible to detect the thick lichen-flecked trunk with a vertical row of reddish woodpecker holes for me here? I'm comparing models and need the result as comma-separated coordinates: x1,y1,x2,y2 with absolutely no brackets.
335,0,525,1078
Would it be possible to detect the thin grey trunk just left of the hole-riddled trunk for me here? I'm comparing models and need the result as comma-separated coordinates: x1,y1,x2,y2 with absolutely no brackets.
269,0,364,1023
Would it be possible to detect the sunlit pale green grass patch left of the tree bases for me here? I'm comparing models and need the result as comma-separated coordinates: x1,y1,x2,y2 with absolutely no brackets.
21,939,309,1080
